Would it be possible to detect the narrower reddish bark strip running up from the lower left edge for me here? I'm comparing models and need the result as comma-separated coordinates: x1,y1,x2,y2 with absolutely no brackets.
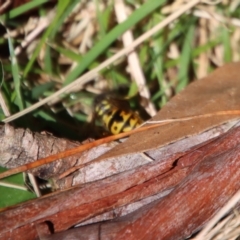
0,152,180,239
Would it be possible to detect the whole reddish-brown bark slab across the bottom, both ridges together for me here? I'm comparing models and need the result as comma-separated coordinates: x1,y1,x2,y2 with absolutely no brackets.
0,124,240,239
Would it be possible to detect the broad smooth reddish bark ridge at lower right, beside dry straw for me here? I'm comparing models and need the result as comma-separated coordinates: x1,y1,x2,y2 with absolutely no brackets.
39,124,240,240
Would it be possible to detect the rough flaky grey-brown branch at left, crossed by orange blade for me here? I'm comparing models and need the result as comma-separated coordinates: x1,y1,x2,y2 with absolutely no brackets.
0,124,79,179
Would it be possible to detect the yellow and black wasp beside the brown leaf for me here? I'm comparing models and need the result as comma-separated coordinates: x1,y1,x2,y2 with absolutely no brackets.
94,96,143,134
